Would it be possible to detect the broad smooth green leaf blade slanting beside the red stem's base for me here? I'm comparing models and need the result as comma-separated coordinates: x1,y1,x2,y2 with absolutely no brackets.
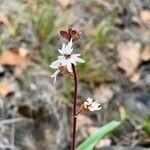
77,121,122,150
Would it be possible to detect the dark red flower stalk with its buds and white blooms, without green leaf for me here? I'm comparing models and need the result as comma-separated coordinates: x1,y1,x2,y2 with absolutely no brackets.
50,28,101,150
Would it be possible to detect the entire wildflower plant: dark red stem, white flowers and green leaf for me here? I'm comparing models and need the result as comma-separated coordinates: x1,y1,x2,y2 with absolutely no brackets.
50,28,126,150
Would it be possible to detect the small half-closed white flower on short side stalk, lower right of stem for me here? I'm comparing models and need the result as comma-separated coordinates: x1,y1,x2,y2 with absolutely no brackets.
83,97,101,111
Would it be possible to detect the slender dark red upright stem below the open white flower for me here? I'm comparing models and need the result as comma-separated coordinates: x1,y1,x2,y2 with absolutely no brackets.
72,64,78,150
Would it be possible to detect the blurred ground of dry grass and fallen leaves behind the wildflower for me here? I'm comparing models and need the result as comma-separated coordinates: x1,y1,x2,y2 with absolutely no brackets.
0,0,150,150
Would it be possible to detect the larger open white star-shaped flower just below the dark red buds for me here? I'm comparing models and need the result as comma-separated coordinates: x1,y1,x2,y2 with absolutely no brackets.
50,40,85,83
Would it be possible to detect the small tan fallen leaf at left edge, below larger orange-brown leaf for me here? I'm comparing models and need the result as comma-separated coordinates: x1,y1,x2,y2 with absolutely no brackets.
0,81,13,96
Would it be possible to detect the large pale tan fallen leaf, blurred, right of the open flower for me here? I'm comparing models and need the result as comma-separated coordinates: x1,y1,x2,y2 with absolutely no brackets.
117,41,141,76
